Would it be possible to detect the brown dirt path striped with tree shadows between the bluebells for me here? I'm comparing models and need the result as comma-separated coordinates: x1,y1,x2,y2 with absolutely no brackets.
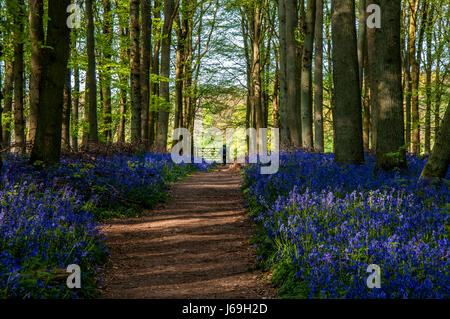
102,169,271,299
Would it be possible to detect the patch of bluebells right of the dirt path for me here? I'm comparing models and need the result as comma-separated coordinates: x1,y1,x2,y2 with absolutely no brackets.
245,151,450,298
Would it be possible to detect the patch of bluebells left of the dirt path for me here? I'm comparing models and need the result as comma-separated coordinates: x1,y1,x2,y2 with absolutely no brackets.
0,154,213,298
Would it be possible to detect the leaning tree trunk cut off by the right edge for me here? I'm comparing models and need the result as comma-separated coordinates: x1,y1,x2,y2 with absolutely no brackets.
420,102,450,180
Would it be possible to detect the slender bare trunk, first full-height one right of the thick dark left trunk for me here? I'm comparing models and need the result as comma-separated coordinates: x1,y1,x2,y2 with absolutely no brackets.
85,0,98,143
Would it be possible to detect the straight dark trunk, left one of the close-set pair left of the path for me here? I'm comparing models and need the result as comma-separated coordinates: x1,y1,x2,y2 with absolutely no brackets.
130,0,142,143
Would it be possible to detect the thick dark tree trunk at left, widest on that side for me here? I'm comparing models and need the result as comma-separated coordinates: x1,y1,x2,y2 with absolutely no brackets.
30,0,70,164
